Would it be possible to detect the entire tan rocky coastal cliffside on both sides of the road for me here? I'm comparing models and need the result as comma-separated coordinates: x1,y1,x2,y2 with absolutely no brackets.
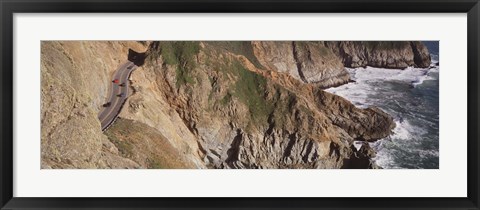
42,42,429,168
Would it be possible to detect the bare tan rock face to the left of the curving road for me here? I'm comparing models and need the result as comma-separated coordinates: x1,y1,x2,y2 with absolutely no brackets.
41,41,145,168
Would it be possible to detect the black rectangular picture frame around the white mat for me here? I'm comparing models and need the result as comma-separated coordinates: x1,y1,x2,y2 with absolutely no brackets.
0,0,480,209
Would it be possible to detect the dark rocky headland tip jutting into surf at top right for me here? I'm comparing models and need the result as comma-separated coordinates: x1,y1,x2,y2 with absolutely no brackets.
325,41,431,69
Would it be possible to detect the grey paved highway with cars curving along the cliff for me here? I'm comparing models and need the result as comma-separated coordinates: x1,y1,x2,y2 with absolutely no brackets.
98,61,138,131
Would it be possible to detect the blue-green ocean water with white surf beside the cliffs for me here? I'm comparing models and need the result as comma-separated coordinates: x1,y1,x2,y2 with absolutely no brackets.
326,42,439,169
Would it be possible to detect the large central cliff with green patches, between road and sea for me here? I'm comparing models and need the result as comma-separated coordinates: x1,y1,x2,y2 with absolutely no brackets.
122,42,394,168
